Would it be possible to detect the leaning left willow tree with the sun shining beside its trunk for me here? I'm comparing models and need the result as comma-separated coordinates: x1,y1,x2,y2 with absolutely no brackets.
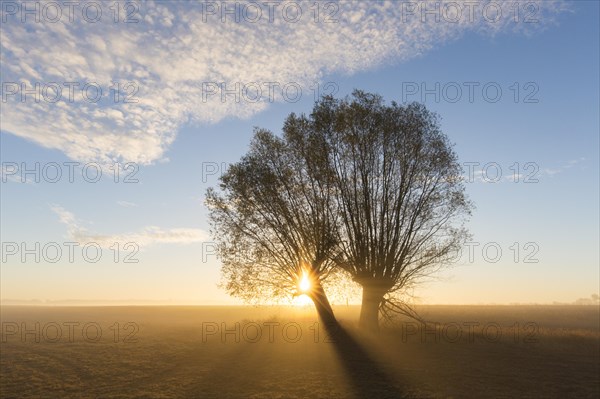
206,126,338,324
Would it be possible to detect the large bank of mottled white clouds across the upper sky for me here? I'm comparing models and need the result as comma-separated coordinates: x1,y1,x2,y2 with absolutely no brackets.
0,1,565,164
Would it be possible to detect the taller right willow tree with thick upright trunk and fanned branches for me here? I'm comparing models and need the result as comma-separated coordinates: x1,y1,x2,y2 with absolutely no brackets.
304,91,472,329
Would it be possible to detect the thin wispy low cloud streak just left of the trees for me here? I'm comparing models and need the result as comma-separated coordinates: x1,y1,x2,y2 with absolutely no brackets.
51,205,208,248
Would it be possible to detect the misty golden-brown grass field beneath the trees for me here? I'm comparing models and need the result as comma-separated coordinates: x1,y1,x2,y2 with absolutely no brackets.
0,306,600,399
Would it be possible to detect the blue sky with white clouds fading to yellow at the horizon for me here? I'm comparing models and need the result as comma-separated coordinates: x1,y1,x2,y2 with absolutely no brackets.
0,1,600,305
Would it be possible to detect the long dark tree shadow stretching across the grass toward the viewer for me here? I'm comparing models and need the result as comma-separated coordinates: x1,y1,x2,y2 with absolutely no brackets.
325,323,411,399
